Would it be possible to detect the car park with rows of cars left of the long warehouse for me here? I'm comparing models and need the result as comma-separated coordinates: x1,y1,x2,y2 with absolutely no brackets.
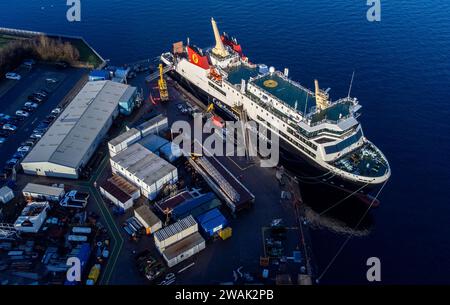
0,64,88,179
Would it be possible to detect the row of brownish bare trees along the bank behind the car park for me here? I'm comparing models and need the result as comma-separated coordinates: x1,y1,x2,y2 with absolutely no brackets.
0,35,80,75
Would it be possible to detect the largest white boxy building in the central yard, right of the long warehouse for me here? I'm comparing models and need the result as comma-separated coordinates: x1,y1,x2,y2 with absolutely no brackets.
110,143,178,200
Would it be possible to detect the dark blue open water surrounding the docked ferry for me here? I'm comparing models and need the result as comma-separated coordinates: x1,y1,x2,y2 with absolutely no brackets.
0,0,450,283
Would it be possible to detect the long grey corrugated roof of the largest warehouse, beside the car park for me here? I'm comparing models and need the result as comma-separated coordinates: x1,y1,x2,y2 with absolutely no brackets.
22,81,135,168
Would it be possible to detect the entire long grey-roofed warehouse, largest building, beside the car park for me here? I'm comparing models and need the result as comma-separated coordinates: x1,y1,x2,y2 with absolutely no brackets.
21,81,136,179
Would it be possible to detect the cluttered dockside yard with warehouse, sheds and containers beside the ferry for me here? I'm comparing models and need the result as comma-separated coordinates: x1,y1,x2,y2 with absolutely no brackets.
0,49,312,285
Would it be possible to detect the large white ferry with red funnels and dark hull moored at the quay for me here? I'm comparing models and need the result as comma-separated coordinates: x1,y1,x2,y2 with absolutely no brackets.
161,18,391,194
